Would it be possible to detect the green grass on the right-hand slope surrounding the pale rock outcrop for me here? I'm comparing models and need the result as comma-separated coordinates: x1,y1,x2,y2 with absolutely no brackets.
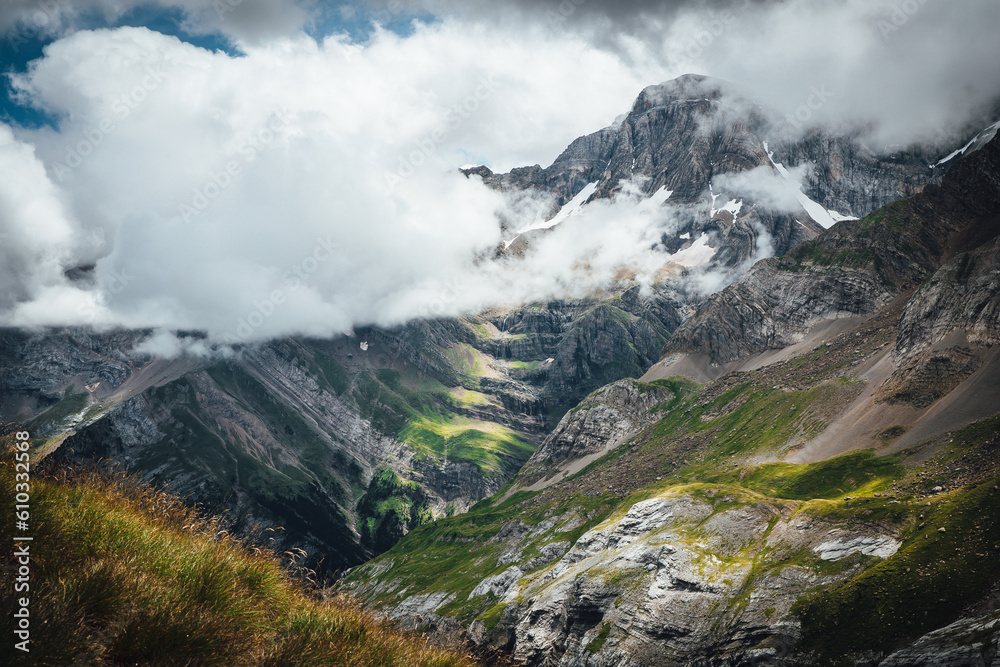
348,302,1000,656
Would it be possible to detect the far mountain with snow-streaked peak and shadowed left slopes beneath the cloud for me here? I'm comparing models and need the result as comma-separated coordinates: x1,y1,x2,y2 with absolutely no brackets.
0,76,981,570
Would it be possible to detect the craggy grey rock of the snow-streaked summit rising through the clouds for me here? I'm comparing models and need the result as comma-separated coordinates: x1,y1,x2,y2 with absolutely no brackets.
465,75,942,280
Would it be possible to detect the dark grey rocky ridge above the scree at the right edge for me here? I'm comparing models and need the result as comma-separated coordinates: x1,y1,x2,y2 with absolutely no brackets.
667,134,1000,362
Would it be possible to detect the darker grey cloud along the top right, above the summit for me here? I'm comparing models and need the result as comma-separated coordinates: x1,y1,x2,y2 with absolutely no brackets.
390,0,1000,149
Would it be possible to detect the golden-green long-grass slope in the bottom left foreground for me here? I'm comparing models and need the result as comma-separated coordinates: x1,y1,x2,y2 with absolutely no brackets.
0,447,472,667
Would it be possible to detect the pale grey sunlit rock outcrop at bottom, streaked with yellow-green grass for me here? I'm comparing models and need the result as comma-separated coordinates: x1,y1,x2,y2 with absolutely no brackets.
440,495,899,667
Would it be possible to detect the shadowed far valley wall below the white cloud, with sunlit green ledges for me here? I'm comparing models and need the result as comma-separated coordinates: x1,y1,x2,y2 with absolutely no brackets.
2,288,680,567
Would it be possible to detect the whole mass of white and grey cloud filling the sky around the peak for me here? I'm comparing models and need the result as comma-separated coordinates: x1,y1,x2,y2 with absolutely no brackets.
0,0,1000,353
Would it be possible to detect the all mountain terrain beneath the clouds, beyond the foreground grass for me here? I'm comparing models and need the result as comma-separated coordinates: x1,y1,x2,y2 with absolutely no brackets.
0,75,1000,667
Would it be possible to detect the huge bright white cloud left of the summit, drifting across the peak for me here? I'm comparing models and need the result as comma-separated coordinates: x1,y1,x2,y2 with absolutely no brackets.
3,21,676,349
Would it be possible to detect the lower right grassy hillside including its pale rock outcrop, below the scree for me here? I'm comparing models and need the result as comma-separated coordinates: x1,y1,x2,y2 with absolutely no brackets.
346,324,1000,664
